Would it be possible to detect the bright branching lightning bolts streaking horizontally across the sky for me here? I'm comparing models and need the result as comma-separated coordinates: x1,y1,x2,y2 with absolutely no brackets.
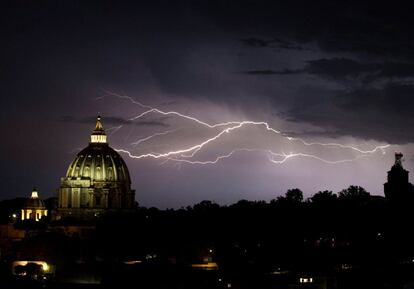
99,91,390,165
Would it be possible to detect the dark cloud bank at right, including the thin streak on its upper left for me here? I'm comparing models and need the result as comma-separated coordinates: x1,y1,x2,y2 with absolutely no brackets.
244,57,414,144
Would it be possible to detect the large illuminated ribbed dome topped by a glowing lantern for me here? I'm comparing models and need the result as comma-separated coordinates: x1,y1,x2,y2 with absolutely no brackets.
56,116,135,219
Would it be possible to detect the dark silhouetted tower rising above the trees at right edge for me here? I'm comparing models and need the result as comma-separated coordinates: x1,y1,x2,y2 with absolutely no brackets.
384,153,414,202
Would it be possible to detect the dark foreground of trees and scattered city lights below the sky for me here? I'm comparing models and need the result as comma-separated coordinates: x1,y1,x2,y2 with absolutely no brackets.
4,186,414,289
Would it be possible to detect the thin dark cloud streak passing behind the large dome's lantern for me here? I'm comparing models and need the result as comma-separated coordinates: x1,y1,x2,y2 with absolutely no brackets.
60,116,169,127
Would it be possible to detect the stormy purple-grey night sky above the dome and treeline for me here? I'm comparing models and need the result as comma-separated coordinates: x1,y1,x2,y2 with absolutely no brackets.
0,0,414,208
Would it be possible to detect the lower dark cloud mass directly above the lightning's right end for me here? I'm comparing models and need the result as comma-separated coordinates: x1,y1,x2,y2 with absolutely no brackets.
285,83,414,144
